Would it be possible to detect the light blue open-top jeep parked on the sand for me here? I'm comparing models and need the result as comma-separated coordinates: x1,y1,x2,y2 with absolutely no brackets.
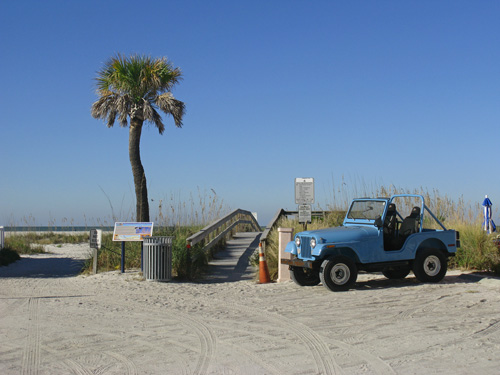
281,194,460,291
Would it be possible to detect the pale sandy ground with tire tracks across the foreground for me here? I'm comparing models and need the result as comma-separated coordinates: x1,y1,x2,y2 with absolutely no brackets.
0,238,500,375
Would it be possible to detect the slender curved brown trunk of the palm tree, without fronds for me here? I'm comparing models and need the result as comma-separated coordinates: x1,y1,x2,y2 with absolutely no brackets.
128,118,149,222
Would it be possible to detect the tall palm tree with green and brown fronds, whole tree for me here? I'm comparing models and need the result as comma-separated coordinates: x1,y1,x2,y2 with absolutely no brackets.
91,55,185,222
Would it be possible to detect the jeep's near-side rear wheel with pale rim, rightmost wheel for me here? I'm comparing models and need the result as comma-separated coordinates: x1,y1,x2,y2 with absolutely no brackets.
413,249,448,283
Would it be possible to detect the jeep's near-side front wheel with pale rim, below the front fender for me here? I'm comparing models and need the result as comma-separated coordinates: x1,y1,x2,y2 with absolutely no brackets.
319,255,358,292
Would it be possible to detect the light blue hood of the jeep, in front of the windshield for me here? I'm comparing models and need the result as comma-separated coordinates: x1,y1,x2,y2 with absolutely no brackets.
297,226,378,244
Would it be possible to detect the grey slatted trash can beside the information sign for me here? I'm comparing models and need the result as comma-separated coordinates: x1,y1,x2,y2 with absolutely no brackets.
143,236,173,281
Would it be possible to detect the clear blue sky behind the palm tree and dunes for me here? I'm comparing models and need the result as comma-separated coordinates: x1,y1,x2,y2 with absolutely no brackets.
0,0,500,225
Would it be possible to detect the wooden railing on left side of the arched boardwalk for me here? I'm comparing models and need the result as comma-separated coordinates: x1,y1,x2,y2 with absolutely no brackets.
186,209,261,251
